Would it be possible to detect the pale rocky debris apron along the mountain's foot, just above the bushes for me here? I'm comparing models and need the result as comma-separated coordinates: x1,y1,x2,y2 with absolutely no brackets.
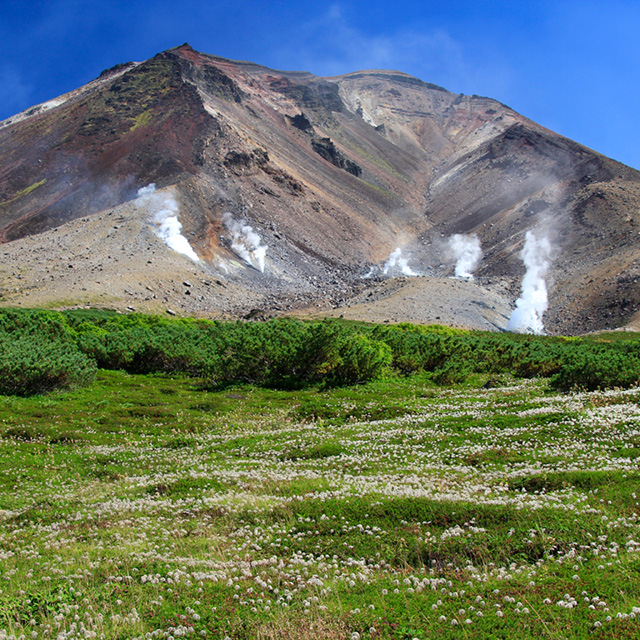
0,196,510,329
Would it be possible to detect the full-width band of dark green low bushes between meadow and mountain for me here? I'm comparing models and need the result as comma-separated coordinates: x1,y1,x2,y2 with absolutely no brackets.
0,310,640,395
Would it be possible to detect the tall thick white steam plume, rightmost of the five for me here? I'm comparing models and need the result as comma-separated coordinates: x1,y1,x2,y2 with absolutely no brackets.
507,231,552,334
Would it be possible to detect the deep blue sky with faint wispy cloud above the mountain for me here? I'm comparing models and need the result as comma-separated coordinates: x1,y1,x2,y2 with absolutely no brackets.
0,0,640,169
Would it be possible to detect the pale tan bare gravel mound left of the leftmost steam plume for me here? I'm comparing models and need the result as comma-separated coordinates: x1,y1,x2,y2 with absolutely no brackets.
0,195,262,315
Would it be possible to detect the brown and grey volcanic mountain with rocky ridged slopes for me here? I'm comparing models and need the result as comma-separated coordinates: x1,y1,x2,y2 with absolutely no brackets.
0,44,640,333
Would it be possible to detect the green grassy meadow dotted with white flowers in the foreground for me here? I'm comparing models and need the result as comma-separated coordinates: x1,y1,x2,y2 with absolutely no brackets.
0,370,640,640
